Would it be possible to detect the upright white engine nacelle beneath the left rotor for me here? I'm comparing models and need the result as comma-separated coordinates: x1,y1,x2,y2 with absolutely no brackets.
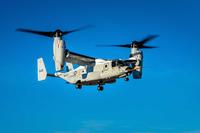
53,37,65,71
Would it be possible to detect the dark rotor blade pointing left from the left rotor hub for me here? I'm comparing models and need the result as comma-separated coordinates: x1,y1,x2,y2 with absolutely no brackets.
16,28,54,37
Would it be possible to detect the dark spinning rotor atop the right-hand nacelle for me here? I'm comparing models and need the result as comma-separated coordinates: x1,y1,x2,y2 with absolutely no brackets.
97,35,158,49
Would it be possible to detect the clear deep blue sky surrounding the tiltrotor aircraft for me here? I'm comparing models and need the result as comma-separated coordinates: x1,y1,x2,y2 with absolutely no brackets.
0,0,200,133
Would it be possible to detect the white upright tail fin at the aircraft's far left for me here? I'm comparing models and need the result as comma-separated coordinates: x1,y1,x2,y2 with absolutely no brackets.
37,58,47,81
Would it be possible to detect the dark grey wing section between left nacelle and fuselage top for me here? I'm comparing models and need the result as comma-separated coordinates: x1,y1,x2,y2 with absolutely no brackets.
65,50,95,66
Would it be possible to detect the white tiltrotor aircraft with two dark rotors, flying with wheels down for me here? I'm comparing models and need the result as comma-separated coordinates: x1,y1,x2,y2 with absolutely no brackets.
17,26,157,91
